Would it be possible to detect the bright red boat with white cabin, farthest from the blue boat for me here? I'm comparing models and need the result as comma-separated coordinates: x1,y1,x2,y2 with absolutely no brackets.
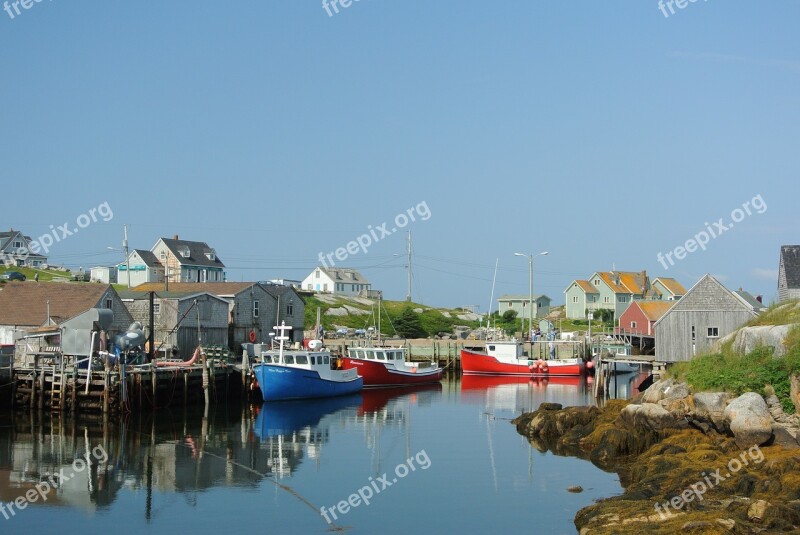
461,340,586,377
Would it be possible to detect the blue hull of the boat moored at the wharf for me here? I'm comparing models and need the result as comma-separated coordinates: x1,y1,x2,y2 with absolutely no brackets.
253,364,364,401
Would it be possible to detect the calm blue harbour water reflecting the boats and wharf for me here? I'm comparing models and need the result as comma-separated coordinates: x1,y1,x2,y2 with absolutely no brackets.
0,378,640,533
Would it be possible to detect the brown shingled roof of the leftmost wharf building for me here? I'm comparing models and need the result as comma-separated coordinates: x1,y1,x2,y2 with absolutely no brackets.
0,282,114,327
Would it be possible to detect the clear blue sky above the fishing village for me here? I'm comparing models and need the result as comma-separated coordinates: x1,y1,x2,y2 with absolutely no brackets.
0,0,800,312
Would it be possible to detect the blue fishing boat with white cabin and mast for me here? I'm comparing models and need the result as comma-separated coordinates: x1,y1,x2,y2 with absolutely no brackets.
253,322,364,401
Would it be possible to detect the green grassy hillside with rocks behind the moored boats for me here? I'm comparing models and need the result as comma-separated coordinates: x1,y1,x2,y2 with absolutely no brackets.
304,295,479,336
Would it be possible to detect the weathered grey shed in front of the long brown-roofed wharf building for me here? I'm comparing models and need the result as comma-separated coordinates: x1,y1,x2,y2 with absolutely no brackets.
120,291,230,359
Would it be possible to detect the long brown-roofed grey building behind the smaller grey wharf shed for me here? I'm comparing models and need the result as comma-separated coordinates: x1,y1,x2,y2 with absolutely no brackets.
131,282,305,346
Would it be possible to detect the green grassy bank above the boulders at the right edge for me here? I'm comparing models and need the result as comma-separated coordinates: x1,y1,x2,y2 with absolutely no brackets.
669,302,800,414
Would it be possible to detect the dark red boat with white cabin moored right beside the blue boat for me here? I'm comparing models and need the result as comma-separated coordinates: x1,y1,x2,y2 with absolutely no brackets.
342,347,443,387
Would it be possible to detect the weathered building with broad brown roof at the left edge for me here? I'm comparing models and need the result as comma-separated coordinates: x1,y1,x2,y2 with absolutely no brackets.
0,282,133,345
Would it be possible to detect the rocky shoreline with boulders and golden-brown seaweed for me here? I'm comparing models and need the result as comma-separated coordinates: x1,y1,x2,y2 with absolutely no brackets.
512,379,800,535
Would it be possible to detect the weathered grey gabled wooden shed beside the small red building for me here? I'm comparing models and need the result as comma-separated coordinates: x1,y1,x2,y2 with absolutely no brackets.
655,274,757,362
